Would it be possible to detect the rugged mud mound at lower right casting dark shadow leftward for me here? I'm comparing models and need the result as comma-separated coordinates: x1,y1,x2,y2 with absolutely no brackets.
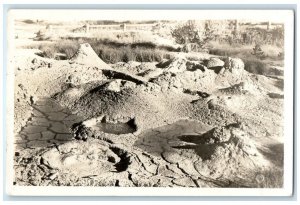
177,124,268,179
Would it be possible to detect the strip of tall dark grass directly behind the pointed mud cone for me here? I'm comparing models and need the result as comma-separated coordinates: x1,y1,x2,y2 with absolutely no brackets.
31,38,174,64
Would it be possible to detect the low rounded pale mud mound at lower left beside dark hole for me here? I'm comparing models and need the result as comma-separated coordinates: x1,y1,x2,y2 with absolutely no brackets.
41,141,120,177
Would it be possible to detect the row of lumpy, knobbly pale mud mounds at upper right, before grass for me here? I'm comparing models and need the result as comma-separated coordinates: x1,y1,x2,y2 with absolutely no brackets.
149,57,252,93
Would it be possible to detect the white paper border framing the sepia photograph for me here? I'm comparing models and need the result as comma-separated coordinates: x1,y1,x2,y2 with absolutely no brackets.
4,4,294,200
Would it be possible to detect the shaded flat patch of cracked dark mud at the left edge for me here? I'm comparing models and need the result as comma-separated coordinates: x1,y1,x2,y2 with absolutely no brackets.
15,98,82,152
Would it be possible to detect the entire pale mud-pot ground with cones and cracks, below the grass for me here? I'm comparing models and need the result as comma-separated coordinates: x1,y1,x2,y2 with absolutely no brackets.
12,44,284,187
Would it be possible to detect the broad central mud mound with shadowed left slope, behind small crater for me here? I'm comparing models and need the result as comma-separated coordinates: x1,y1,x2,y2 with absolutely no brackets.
56,79,193,132
